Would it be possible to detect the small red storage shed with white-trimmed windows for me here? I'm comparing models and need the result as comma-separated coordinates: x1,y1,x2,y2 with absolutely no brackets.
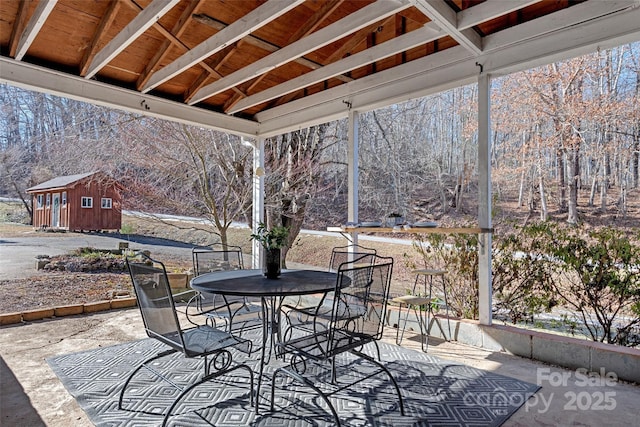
27,172,122,231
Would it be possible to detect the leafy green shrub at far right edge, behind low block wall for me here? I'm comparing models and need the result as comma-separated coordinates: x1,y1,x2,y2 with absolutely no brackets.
545,225,640,345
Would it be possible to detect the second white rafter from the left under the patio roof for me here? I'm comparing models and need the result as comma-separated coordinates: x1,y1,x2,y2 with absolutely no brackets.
85,0,180,79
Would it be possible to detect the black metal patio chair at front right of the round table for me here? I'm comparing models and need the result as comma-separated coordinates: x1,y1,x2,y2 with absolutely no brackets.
271,255,404,425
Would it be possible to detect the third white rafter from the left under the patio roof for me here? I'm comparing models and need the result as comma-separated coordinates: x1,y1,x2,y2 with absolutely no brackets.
142,0,304,93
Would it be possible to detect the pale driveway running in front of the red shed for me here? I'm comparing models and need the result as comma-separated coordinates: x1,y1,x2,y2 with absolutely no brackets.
0,233,192,280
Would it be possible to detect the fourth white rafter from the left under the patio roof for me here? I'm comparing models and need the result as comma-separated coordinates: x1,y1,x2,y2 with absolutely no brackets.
189,0,411,105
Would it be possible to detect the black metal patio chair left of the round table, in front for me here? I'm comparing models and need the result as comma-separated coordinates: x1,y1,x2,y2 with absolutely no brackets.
118,254,254,426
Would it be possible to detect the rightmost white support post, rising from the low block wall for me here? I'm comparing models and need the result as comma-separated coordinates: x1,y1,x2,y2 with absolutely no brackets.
478,73,493,325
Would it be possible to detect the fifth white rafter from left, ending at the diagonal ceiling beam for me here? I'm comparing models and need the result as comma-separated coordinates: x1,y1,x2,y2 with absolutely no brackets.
227,23,444,114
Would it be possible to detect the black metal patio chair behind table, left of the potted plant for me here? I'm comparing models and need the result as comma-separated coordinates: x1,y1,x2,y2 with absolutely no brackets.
187,244,262,334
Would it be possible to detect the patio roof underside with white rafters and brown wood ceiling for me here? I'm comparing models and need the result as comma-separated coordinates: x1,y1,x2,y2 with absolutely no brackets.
0,0,640,138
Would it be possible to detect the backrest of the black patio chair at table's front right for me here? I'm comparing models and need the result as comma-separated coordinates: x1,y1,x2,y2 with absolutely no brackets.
332,254,393,343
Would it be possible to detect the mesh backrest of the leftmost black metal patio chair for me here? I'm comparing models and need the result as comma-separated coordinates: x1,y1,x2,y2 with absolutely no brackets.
126,253,185,352
